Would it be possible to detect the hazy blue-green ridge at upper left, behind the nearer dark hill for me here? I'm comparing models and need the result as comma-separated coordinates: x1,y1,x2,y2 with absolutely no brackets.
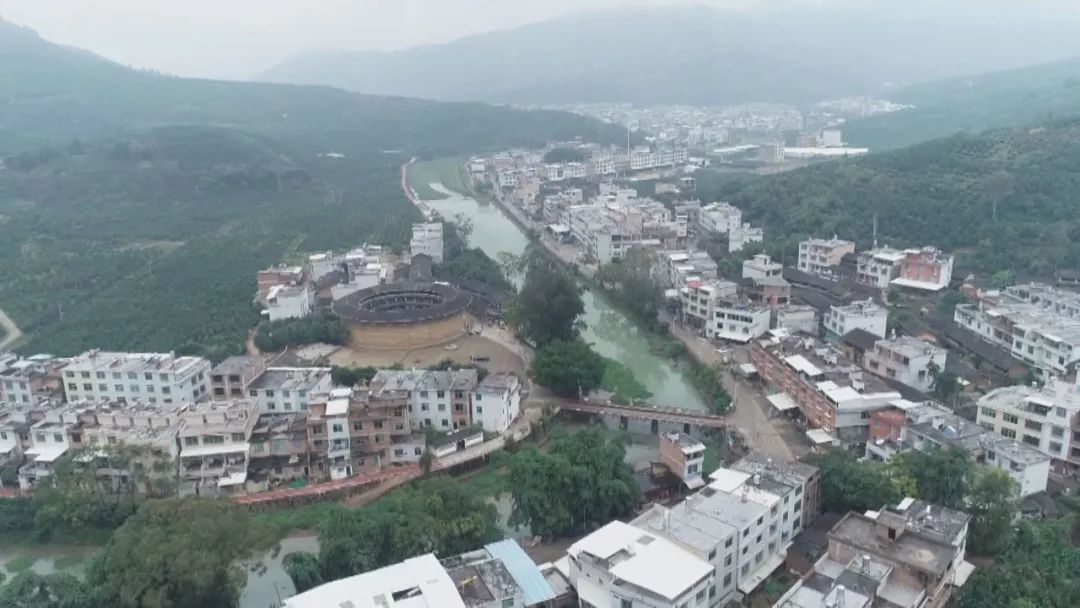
0,21,623,154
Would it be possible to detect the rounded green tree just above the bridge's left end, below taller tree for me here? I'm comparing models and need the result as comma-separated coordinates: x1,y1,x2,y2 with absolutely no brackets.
530,338,609,397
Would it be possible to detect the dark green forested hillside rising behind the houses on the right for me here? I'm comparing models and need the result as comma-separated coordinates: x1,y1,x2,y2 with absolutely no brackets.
699,119,1080,275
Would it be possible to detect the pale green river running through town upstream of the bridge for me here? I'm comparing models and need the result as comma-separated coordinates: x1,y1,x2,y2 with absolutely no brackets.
424,184,706,410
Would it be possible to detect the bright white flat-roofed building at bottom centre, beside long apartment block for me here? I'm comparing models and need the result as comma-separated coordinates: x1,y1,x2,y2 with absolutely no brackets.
567,521,718,608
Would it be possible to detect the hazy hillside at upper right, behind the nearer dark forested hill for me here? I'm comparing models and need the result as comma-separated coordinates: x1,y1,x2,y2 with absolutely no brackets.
843,58,1080,150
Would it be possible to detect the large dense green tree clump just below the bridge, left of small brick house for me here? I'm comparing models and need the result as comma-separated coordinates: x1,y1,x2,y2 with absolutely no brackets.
509,428,638,537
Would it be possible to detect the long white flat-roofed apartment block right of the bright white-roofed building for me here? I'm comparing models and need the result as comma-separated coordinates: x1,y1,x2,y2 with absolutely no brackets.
632,455,818,606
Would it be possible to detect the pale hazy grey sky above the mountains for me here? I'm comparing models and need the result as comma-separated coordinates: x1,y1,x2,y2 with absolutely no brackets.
0,0,1080,79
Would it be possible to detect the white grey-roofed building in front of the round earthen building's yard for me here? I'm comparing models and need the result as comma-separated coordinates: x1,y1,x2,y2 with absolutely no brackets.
369,369,481,431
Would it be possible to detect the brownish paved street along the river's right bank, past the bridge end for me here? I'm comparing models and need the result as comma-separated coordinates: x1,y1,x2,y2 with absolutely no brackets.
672,323,809,460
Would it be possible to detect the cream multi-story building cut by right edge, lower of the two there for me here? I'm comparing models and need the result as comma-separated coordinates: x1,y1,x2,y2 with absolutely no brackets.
975,377,1080,474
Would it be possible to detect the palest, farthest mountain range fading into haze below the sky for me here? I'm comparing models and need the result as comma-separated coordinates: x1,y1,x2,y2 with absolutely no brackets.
255,4,1080,105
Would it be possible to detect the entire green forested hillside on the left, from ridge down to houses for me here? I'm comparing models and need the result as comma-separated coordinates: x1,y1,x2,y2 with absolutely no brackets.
0,22,622,359
